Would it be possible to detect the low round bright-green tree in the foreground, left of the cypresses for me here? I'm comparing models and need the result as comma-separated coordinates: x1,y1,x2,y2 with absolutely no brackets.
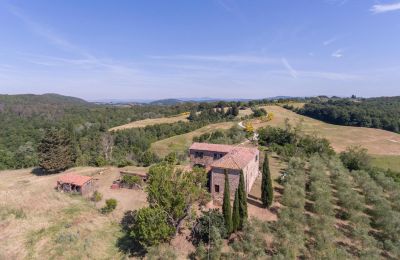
131,207,175,248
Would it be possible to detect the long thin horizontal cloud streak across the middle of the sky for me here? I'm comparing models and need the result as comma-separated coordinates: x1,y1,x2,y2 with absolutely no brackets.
150,54,280,64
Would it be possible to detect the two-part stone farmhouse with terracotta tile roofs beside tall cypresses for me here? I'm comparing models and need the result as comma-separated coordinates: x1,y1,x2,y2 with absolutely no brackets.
189,143,260,203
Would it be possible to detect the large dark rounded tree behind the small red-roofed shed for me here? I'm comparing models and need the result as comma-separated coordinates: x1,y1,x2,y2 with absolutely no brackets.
38,128,76,173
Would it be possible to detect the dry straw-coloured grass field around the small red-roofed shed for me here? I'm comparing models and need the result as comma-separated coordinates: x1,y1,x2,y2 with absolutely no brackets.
0,167,147,259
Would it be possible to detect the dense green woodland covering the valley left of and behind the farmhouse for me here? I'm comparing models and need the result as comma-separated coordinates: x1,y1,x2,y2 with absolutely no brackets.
0,94,271,170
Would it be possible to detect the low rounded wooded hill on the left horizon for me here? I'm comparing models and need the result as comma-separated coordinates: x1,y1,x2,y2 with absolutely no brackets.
0,94,94,117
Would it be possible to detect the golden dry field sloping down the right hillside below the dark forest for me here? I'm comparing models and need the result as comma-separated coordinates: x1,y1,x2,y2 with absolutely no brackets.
253,106,400,155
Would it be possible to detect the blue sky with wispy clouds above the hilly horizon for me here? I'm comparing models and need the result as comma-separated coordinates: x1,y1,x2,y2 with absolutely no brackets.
0,0,400,100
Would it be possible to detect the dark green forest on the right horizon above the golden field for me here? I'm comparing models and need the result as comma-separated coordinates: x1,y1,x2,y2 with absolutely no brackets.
285,97,400,133
